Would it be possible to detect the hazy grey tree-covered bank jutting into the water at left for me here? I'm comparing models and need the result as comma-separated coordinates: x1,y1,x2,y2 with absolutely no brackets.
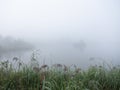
0,36,34,59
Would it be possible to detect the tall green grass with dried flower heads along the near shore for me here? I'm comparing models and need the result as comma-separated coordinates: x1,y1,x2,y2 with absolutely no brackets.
0,58,120,90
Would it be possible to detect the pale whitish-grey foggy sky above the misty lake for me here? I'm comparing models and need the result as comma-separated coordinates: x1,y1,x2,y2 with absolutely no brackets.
0,0,120,40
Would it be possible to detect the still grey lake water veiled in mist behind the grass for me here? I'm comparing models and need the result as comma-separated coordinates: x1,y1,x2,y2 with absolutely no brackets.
2,42,120,68
